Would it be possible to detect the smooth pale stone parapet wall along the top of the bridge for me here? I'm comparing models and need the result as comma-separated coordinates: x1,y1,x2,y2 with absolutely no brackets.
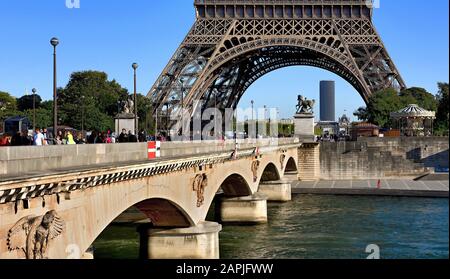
0,139,298,180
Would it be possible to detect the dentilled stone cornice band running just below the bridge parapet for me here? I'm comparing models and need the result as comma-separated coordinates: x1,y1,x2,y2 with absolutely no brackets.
0,143,301,208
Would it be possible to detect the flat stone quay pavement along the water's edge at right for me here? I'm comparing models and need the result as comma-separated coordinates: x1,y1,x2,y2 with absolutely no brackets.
292,179,449,198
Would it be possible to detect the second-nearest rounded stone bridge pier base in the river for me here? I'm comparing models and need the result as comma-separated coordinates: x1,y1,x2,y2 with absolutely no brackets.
219,193,268,224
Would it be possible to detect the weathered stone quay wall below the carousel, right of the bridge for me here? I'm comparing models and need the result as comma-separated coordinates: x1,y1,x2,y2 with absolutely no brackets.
320,137,449,180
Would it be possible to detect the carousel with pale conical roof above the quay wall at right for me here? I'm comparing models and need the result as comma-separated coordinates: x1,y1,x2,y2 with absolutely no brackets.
391,105,436,137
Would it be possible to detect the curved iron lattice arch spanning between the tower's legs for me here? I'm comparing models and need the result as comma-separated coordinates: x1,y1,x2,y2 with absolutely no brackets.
187,38,370,114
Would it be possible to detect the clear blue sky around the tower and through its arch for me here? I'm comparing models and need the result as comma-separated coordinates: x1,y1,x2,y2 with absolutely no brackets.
0,0,449,121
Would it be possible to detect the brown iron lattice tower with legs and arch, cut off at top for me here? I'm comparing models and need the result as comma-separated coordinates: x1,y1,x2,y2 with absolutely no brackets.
148,0,406,126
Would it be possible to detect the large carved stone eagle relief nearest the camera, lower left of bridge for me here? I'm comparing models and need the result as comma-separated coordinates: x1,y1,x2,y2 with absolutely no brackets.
7,210,65,259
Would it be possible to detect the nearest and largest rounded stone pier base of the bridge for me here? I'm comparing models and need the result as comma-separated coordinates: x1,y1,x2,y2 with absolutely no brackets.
138,222,222,259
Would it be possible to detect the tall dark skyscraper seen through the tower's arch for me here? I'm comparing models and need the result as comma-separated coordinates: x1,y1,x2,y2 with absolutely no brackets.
320,81,336,122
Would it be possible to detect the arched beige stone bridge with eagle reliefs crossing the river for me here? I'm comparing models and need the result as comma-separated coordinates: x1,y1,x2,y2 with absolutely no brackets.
0,141,320,259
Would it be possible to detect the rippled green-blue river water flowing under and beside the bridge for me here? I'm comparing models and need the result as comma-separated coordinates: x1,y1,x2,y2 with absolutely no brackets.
94,195,449,259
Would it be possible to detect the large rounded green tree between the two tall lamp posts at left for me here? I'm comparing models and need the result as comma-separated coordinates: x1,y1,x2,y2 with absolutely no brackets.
58,71,128,131
